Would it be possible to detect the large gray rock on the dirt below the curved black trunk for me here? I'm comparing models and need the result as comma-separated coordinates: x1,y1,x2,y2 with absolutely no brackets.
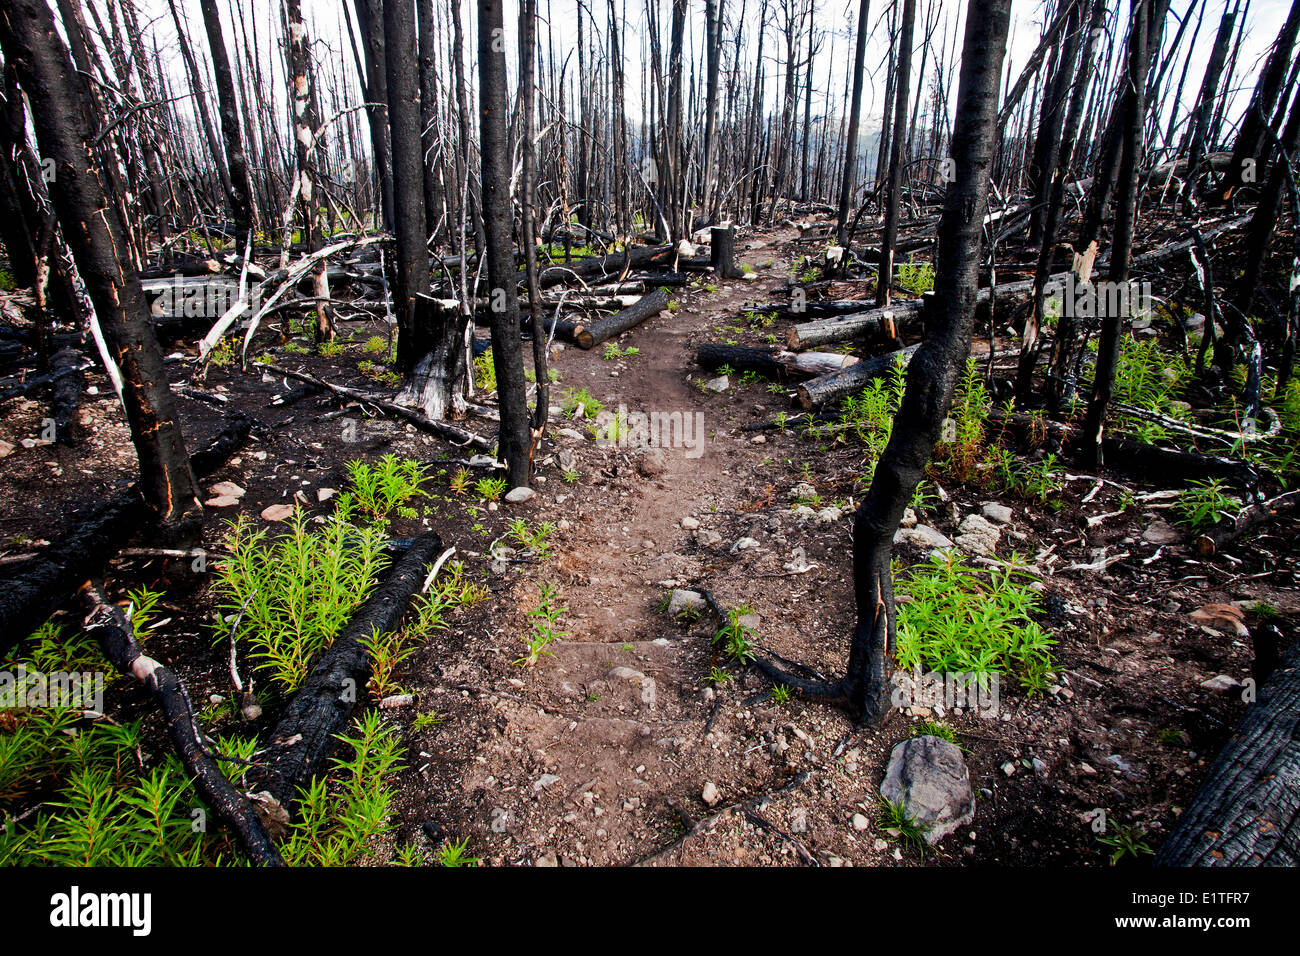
880,736,975,845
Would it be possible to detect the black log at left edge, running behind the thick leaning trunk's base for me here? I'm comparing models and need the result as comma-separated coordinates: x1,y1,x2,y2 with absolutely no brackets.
0,414,252,656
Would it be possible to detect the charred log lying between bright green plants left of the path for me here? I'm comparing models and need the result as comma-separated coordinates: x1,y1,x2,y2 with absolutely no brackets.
246,531,442,810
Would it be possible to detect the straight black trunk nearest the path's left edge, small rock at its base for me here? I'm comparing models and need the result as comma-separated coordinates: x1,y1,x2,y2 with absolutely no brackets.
478,0,529,488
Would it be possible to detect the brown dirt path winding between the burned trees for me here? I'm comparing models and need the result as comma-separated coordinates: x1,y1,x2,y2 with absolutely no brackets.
390,231,889,865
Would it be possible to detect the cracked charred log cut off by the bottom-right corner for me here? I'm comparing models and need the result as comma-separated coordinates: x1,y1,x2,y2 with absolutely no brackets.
1154,643,1300,866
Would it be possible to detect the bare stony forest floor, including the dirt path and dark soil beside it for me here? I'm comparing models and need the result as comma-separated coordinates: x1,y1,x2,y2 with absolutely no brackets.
0,218,1300,866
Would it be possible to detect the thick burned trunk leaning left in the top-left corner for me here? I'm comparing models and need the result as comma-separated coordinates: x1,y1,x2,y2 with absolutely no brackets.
0,0,202,525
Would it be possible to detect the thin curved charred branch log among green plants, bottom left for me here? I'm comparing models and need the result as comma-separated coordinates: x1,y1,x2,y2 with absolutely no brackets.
81,581,285,866
